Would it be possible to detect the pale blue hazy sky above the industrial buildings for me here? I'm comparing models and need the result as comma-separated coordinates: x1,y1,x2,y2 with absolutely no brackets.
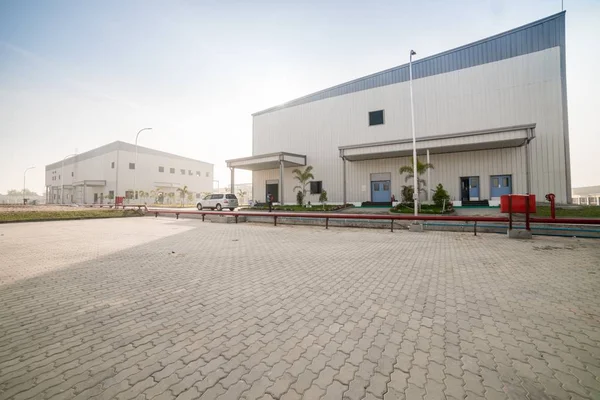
0,0,600,193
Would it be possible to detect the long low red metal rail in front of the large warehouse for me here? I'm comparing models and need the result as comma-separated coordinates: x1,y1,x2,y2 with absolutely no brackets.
148,209,600,235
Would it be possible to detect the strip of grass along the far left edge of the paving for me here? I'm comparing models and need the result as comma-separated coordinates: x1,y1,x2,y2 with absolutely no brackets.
0,210,141,223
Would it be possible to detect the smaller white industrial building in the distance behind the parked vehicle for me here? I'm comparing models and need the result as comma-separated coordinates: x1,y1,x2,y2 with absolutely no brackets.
46,141,214,204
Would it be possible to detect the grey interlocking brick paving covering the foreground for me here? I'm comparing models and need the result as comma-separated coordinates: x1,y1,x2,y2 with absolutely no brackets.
0,218,600,399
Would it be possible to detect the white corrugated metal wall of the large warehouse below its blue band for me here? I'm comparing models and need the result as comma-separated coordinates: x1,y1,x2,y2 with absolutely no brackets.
253,47,569,202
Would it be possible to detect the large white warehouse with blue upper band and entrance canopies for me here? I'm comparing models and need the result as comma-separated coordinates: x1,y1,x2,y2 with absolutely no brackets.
227,12,571,205
